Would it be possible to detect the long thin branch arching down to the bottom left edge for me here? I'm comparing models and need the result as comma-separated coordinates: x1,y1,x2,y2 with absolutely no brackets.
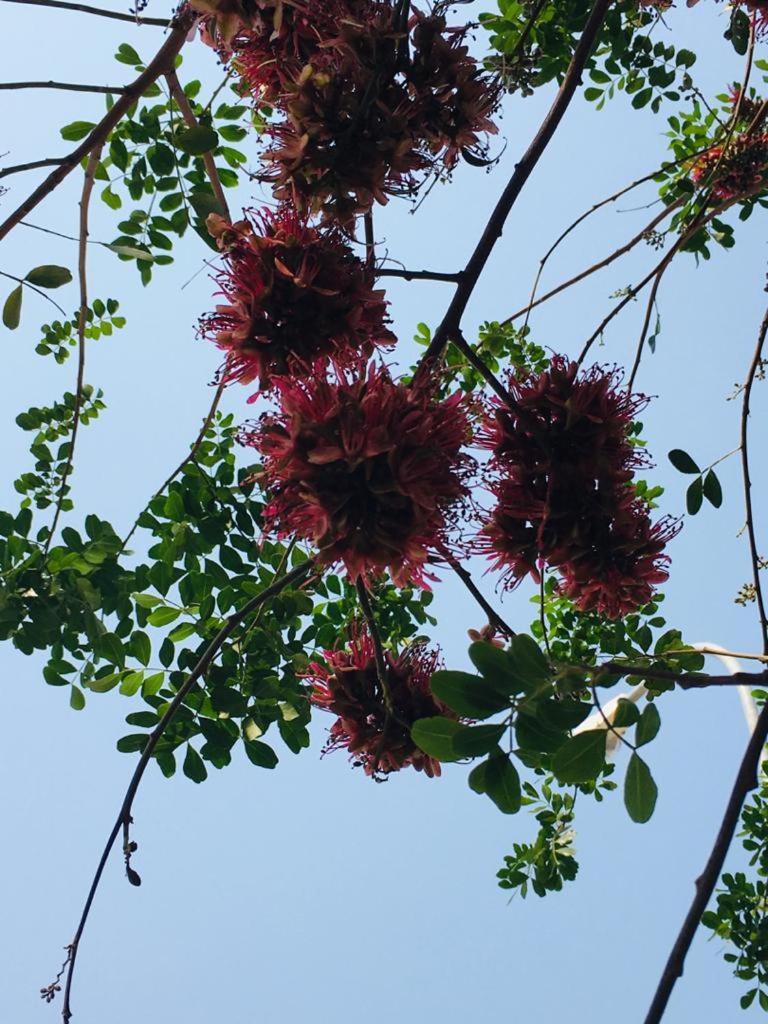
56,558,314,1024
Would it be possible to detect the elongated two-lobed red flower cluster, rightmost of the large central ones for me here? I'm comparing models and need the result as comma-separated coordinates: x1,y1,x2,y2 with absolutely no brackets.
478,356,677,617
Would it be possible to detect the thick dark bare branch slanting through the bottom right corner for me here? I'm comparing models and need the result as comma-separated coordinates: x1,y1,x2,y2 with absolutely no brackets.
645,705,768,1024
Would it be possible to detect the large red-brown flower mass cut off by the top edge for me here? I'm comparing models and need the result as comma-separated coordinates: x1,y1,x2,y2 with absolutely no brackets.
195,0,501,224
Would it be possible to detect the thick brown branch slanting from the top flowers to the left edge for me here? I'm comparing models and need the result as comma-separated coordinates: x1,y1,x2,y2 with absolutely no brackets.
0,12,193,239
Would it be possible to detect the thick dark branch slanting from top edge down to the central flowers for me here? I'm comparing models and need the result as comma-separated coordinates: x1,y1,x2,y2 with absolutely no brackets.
419,0,611,372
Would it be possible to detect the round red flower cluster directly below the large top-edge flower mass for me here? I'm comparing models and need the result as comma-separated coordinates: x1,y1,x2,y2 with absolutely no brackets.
201,208,394,387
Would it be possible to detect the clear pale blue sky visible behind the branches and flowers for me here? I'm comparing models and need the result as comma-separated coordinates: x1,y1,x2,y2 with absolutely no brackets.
0,0,768,1024
